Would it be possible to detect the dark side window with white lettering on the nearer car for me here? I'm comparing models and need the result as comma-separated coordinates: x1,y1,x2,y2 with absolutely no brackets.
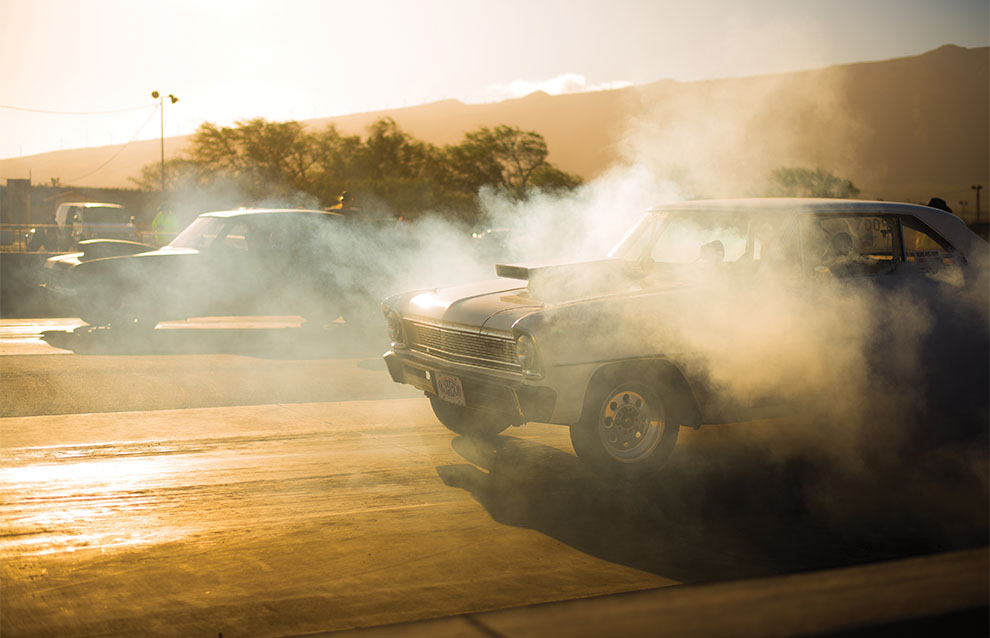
802,215,896,277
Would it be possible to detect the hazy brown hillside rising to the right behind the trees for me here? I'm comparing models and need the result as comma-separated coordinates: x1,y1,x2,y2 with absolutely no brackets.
0,45,990,215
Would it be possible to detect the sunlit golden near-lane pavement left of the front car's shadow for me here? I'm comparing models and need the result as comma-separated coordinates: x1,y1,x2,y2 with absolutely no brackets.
0,398,675,636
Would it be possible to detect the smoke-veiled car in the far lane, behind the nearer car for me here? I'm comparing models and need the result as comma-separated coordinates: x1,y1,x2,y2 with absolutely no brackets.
45,209,380,329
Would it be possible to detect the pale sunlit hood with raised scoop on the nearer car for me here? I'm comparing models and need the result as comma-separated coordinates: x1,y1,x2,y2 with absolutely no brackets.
396,260,660,332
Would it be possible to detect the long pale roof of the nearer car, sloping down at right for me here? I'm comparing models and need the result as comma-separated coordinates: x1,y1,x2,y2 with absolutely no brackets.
647,197,990,258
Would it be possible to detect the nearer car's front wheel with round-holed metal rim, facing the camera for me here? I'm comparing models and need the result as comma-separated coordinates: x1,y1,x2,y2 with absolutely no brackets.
571,370,680,477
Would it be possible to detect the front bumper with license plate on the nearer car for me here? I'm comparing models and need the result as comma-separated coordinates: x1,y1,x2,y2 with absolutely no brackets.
384,350,557,425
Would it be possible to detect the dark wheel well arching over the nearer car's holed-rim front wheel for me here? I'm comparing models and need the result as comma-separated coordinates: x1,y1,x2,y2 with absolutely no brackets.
581,359,701,427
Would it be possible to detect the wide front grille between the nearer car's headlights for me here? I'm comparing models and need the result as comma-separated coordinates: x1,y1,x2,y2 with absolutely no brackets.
406,321,521,372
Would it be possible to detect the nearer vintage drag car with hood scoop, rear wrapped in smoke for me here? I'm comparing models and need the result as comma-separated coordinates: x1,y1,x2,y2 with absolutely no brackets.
382,199,988,474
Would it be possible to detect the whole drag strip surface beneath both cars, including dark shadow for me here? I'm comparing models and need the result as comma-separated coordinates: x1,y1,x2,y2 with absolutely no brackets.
0,318,988,638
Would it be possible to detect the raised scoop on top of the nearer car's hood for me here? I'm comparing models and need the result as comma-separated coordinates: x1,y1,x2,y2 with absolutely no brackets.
495,259,633,302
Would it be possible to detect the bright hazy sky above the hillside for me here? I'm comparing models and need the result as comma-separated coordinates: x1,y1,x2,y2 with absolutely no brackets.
0,0,990,158
